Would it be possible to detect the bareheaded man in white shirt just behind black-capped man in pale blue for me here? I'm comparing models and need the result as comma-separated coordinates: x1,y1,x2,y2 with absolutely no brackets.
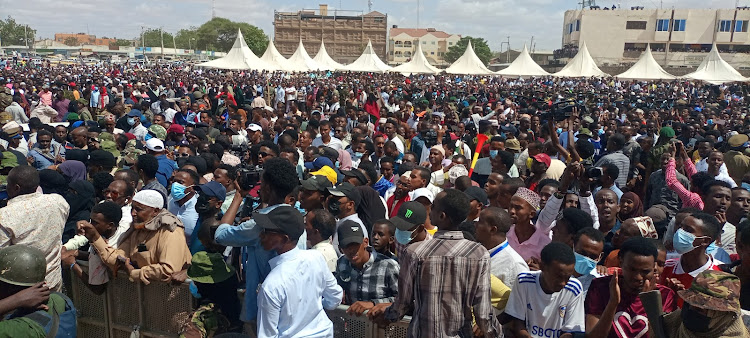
305,209,339,272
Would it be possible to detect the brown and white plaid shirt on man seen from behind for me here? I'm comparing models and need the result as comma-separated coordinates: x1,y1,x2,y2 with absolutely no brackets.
385,231,499,337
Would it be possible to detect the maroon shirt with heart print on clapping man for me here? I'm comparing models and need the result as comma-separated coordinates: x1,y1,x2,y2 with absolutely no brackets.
584,276,678,338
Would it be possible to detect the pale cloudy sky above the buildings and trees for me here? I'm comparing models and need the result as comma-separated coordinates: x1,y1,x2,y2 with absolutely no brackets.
0,0,750,51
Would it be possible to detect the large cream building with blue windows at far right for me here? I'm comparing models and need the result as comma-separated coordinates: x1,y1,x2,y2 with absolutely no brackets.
555,7,750,67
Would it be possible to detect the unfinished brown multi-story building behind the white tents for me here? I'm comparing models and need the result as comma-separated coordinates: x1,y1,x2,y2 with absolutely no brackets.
273,5,388,63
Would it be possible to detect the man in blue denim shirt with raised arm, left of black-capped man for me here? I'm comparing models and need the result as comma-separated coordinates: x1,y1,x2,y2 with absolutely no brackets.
214,158,307,332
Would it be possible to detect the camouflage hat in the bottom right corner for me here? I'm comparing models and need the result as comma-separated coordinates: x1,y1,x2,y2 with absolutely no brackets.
677,270,740,312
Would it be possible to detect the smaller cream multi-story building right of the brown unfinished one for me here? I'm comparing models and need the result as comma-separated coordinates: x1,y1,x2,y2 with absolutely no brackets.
388,25,461,67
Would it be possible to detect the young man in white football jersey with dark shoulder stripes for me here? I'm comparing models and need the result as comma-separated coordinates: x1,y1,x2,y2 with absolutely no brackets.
506,242,586,337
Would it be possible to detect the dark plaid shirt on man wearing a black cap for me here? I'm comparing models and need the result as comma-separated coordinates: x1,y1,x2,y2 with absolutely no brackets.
336,247,399,305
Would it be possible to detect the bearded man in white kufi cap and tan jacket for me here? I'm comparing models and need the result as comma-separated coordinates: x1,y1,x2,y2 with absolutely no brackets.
79,190,191,284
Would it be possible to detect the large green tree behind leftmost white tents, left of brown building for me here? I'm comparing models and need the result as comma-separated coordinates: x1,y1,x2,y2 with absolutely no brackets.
192,18,268,55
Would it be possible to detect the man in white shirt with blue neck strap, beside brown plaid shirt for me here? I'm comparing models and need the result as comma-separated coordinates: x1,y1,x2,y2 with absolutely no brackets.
476,207,529,290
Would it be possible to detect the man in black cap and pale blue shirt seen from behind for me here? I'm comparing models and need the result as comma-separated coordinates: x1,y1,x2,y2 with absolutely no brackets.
253,205,344,338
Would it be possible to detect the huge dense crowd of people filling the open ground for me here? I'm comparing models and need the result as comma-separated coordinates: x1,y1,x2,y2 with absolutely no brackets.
0,59,750,338
